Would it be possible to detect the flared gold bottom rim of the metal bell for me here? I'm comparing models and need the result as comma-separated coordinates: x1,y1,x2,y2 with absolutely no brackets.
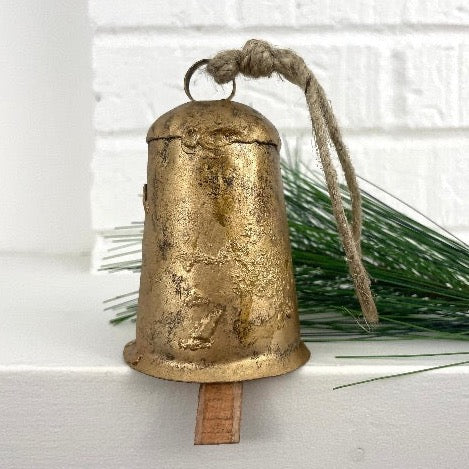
123,340,311,383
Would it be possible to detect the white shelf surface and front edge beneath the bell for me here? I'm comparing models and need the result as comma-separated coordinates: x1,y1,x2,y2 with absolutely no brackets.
0,256,469,469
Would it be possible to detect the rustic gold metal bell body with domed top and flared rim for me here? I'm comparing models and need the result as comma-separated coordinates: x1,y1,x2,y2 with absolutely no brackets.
124,100,309,382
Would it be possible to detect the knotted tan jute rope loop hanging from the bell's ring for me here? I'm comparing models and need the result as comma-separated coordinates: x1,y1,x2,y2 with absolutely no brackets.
206,39,378,324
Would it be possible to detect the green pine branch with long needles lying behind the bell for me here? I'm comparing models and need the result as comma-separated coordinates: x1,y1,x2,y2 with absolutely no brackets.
101,161,469,341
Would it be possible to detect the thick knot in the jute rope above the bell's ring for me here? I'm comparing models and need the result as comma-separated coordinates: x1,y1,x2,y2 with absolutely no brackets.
207,39,275,85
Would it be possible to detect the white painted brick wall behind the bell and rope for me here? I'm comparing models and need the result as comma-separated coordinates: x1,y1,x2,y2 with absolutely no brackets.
89,0,469,264
